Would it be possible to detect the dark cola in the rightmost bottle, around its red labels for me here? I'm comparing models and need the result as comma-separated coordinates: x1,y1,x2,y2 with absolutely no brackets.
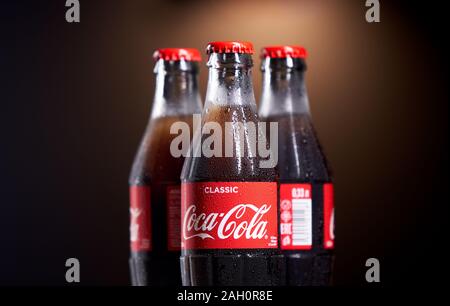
262,115,333,286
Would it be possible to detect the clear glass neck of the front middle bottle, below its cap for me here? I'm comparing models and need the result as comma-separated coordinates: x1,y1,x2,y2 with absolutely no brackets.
205,53,256,109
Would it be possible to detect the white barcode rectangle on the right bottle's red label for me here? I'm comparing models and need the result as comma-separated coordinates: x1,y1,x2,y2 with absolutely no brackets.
292,199,312,246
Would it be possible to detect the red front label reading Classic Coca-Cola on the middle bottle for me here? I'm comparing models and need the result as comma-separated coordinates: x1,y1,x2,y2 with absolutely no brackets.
181,182,278,249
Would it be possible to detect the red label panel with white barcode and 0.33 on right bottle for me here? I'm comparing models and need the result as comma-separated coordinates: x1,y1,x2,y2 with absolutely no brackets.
280,184,312,250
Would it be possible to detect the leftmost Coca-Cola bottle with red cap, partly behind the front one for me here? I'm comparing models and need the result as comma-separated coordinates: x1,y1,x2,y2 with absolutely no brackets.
129,48,201,286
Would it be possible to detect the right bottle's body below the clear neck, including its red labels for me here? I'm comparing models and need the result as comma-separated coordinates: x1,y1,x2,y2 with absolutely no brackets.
266,115,334,286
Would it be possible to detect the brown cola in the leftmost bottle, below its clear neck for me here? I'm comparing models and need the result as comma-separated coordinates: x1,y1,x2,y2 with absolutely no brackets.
130,115,192,286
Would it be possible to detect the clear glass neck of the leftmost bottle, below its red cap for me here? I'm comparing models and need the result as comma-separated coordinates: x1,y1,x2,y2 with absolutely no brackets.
151,59,201,118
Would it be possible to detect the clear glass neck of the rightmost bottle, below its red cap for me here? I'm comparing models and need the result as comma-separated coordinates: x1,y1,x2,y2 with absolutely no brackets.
259,58,310,118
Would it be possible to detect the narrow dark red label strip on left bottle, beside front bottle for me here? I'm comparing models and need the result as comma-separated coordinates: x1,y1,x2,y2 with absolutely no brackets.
166,185,181,251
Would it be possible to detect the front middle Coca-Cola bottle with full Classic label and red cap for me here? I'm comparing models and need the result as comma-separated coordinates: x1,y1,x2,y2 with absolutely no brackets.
181,42,283,286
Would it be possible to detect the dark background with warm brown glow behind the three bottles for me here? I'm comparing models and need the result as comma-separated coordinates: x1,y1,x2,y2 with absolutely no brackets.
0,0,449,286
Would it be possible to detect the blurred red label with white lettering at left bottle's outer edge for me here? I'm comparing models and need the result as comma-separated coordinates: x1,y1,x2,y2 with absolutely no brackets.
130,186,151,252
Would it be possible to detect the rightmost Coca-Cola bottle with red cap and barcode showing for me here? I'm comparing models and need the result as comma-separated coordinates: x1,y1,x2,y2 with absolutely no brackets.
259,46,334,285
